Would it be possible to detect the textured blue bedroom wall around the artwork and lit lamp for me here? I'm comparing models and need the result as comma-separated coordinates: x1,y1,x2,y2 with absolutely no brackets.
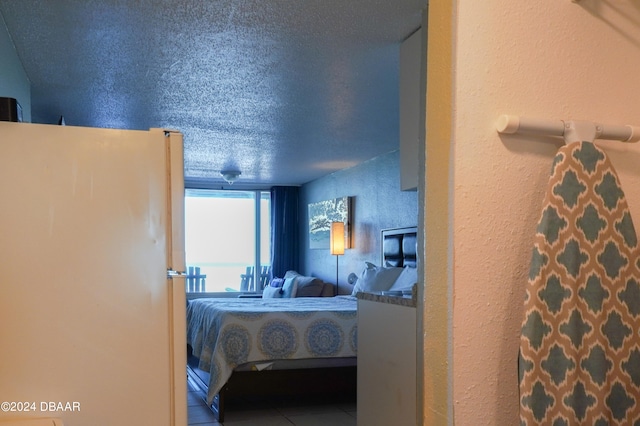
299,151,418,292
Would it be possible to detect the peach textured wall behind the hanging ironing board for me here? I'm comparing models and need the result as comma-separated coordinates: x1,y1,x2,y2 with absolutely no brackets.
424,0,640,425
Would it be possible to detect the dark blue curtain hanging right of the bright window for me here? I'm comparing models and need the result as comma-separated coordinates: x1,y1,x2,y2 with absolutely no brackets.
271,186,299,278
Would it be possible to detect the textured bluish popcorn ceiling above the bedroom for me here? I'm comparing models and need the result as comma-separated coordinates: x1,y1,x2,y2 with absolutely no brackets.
0,0,427,186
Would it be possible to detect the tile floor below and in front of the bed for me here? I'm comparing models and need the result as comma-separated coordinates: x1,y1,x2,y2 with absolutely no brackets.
187,383,356,426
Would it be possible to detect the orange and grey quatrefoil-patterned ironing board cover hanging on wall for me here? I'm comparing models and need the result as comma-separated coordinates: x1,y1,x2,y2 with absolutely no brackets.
518,142,640,426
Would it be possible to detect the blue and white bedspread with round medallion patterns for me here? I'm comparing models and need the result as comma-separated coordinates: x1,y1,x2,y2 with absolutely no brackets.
187,296,357,404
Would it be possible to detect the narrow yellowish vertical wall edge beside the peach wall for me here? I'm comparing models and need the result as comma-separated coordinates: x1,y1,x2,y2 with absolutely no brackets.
418,1,453,425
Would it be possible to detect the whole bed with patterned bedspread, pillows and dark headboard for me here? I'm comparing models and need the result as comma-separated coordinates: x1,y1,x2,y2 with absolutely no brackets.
187,227,417,422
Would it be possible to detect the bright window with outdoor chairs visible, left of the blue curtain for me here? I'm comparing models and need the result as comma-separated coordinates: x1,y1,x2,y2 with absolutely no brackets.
185,188,271,292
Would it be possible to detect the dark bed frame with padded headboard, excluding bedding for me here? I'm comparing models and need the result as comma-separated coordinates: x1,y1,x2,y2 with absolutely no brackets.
187,227,417,423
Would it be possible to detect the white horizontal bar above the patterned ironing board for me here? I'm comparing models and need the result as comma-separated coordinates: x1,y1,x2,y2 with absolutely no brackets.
496,115,640,143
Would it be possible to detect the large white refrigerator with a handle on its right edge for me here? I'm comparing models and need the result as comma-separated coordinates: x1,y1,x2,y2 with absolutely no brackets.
0,122,187,426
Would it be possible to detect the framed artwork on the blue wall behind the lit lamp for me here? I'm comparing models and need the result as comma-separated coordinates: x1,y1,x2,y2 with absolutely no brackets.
309,197,353,249
